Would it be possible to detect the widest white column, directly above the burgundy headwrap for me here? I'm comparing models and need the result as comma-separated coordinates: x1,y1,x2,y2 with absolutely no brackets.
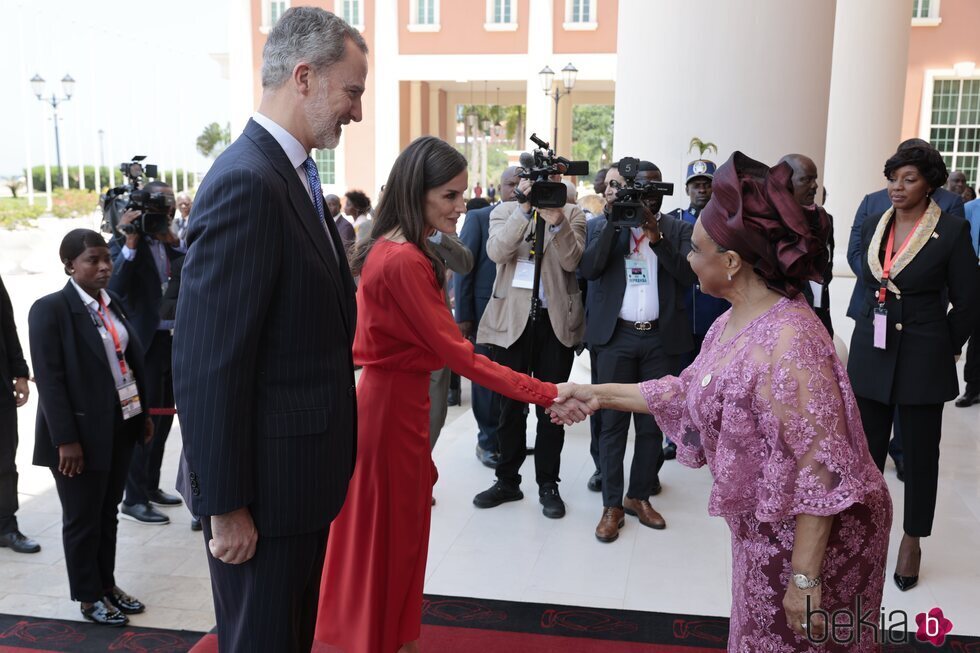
613,0,832,191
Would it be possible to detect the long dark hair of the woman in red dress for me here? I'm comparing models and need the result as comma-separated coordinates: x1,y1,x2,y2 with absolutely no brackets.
351,136,466,287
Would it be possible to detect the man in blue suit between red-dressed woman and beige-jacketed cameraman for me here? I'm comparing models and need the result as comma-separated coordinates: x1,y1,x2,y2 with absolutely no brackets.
453,166,520,469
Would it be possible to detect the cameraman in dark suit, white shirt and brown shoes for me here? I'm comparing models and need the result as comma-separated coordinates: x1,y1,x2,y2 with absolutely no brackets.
581,158,697,542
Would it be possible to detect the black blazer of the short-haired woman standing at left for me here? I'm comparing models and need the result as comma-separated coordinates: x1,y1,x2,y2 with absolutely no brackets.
27,281,148,472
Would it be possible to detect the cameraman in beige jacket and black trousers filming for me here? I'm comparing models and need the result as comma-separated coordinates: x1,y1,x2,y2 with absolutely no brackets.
473,135,588,519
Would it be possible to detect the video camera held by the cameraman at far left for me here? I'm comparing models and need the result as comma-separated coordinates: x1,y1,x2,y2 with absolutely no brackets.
101,155,174,235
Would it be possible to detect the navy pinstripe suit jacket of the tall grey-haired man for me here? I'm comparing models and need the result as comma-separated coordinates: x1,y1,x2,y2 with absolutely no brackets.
173,120,357,536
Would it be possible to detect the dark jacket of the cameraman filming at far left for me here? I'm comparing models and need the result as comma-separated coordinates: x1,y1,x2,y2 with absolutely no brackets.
109,237,184,347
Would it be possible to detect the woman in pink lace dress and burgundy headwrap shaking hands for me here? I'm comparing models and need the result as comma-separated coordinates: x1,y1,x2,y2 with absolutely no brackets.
559,153,892,653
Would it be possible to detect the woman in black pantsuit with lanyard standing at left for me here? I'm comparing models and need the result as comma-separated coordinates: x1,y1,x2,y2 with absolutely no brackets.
28,229,153,626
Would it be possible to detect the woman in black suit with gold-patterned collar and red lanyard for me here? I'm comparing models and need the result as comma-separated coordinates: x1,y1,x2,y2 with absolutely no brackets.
847,146,980,591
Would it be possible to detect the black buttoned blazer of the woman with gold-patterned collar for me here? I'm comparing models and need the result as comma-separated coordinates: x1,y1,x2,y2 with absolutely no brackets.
847,213,980,405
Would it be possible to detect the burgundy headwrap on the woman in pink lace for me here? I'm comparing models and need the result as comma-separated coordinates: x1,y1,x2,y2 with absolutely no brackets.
699,152,830,297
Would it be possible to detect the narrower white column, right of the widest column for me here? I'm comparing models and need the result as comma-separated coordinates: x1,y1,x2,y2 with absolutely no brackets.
822,0,910,276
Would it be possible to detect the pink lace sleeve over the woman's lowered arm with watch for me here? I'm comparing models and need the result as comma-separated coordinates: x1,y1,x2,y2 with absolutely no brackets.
755,320,880,521
